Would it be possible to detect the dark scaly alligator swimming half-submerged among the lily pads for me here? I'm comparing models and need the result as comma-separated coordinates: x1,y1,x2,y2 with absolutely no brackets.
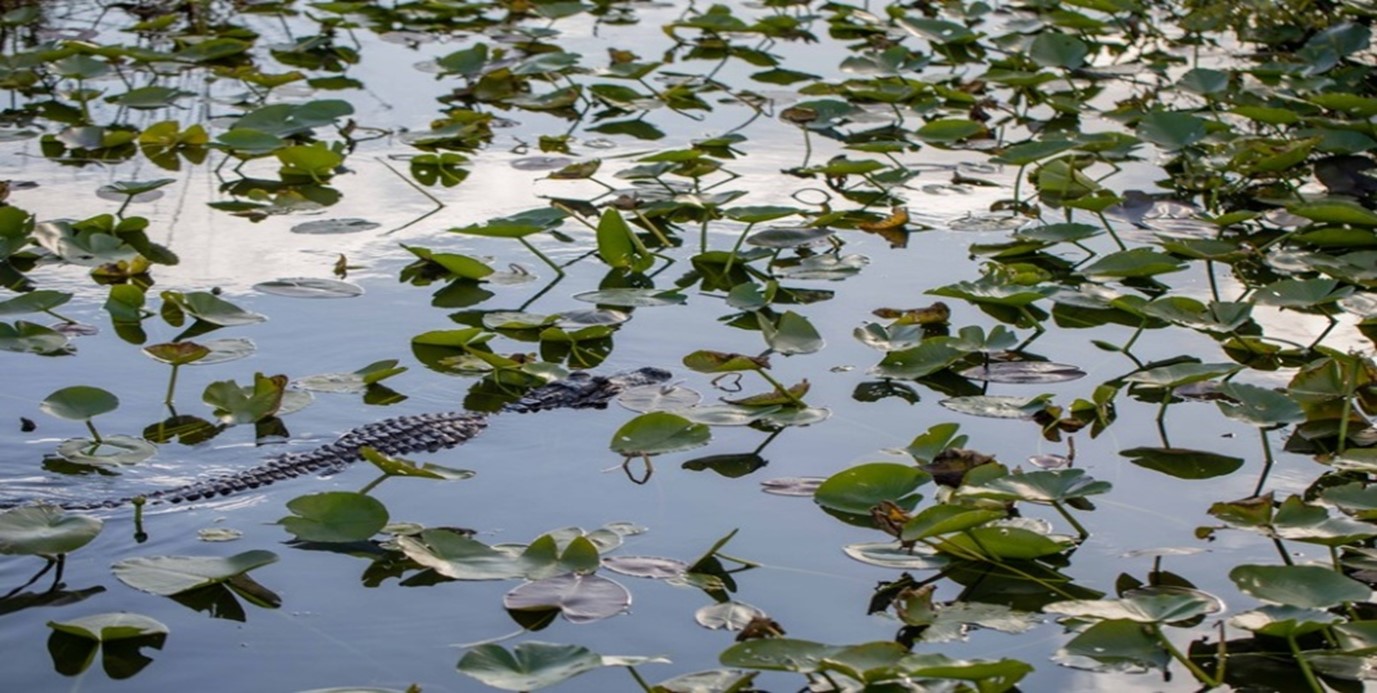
0,366,671,510
